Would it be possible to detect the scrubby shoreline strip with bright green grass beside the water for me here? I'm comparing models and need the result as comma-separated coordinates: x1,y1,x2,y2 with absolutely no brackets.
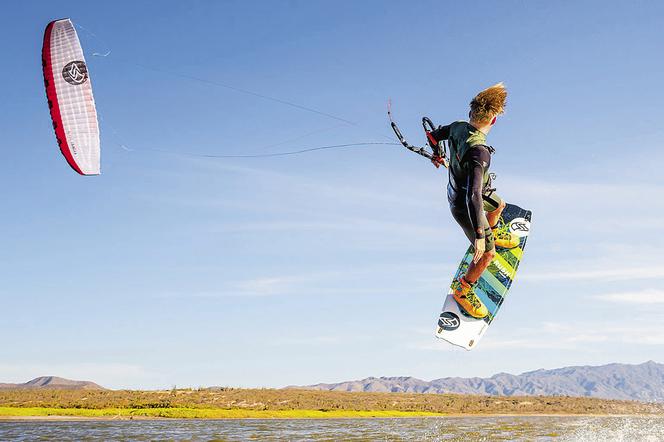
0,388,664,419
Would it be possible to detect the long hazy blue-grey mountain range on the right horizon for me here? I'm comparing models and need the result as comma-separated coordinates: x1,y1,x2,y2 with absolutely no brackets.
287,361,664,402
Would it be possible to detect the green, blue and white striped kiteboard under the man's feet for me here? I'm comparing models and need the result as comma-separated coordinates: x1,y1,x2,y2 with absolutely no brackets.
436,204,532,350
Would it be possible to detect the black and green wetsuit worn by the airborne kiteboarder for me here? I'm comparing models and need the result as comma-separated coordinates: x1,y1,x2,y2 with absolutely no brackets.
432,121,502,250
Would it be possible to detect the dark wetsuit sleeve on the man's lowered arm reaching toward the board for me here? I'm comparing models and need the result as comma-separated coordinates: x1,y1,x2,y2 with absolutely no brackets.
466,145,491,239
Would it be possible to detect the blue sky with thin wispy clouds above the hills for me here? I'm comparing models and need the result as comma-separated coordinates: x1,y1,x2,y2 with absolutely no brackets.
0,1,664,388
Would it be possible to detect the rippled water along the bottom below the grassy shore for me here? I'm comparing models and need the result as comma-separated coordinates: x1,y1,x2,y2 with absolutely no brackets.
0,416,664,442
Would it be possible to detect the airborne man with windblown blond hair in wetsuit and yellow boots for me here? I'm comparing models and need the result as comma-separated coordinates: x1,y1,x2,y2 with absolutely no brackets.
431,83,519,319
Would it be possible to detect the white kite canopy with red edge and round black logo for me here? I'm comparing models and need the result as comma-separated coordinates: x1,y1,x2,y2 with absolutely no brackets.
42,18,100,175
